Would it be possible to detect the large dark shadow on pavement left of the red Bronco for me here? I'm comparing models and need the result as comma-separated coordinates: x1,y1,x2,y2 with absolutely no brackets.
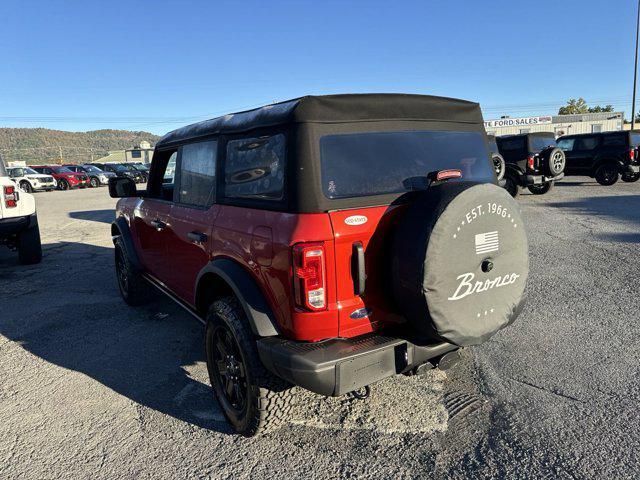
0,242,232,433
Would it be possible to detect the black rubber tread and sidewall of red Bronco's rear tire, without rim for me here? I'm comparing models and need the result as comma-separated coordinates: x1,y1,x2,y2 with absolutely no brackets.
205,297,295,437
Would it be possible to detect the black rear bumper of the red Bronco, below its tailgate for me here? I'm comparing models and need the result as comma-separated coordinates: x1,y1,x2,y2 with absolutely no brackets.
257,334,458,396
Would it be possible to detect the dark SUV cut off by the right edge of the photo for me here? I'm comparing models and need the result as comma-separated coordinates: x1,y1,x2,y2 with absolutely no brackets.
558,131,640,185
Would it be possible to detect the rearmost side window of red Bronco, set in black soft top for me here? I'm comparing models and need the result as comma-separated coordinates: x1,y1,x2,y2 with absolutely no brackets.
224,133,286,200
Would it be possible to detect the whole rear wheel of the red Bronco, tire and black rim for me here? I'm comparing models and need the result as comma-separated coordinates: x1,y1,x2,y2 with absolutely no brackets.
205,297,293,437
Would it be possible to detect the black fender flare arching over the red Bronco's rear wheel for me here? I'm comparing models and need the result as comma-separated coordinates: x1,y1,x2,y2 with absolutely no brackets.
195,258,279,337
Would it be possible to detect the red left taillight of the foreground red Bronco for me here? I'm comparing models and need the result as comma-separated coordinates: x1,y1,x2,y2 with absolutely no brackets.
293,243,327,312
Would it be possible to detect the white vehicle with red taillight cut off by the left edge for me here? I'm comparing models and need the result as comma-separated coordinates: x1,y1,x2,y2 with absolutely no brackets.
0,157,42,264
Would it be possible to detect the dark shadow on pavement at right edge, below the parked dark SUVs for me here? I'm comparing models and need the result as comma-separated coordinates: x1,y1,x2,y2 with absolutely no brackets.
545,195,640,243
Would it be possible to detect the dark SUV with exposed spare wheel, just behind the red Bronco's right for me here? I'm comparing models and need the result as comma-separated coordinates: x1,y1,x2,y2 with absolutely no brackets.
496,132,565,197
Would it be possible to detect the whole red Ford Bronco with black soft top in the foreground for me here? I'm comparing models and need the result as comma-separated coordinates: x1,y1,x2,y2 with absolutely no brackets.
109,94,528,435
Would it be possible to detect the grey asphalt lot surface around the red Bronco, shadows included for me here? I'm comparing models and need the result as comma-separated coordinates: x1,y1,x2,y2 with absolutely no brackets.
0,178,640,479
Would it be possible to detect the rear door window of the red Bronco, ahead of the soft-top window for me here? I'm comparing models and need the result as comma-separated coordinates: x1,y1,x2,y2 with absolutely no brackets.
176,140,218,207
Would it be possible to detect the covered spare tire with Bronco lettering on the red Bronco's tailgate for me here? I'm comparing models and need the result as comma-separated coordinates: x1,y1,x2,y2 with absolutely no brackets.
392,182,529,346
